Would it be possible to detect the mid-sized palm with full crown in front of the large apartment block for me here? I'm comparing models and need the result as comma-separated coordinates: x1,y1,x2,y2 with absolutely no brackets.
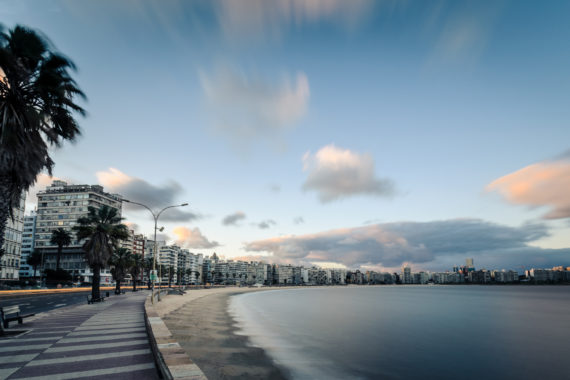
73,206,129,299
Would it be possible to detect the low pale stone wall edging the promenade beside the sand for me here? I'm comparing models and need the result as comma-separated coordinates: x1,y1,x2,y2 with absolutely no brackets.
144,292,208,380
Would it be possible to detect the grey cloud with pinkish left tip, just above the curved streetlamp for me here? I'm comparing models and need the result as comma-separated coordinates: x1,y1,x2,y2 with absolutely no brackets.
96,168,202,222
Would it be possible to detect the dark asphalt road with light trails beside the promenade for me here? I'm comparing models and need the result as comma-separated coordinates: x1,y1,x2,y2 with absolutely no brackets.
0,289,129,314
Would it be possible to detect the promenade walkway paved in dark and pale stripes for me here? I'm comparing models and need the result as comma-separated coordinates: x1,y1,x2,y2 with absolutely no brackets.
0,291,158,380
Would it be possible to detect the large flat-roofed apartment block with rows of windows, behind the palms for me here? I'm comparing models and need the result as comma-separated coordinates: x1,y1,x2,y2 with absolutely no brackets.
34,181,122,284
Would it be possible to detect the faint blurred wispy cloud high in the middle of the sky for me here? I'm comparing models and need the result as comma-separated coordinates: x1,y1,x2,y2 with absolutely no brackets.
200,67,310,149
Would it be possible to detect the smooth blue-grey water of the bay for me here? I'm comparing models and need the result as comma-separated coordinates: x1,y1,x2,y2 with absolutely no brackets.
229,285,570,379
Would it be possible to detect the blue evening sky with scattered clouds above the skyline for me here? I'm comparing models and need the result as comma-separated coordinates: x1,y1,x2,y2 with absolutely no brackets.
0,0,570,271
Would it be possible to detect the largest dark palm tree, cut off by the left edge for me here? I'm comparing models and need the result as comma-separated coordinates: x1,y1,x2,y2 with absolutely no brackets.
0,25,85,256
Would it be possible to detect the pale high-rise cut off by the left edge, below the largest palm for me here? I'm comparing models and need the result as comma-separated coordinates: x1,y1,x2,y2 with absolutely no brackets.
0,193,26,280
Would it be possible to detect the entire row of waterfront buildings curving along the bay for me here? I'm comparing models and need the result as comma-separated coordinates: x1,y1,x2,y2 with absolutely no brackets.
2,200,570,286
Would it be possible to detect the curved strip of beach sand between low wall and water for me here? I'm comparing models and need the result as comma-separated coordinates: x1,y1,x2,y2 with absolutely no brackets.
157,288,289,380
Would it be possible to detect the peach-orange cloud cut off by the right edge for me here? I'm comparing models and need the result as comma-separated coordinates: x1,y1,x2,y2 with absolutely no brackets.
486,155,570,219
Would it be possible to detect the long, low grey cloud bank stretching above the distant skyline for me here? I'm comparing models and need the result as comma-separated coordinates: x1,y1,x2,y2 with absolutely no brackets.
244,219,570,270
